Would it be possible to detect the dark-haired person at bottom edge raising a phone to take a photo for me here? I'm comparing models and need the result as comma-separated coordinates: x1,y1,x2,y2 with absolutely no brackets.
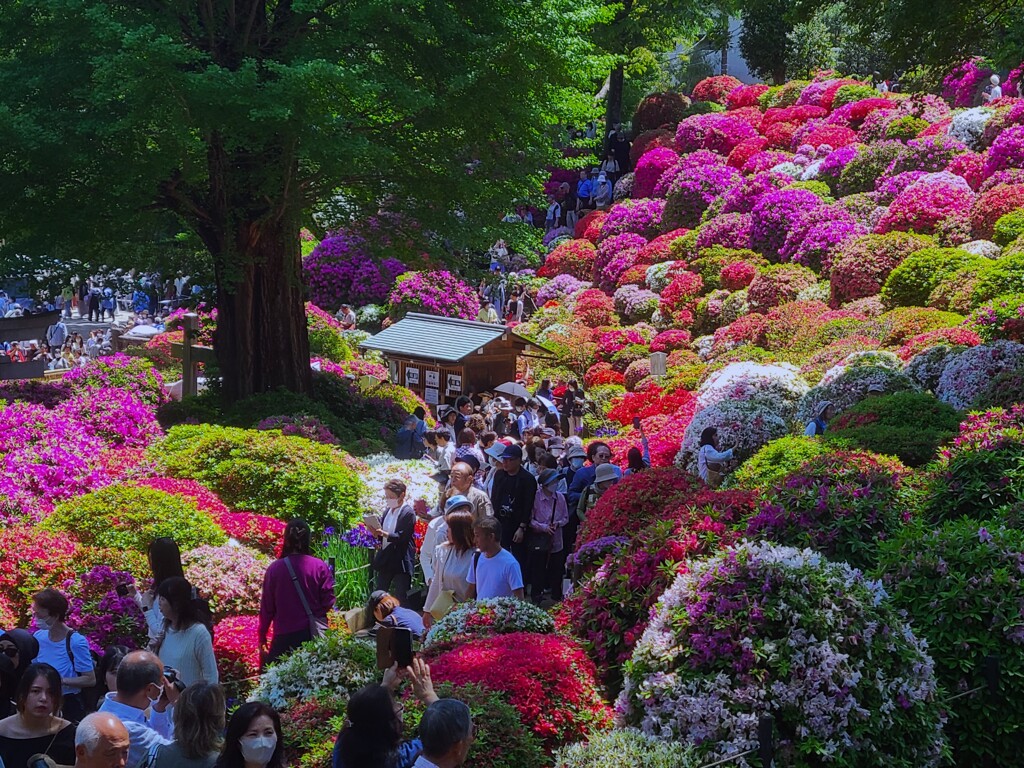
333,657,437,768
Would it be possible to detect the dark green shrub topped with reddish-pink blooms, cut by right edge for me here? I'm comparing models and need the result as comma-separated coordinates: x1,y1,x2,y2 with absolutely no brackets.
922,406,1024,527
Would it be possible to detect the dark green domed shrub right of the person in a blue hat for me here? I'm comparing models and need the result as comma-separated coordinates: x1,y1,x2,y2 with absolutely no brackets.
825,392,959,467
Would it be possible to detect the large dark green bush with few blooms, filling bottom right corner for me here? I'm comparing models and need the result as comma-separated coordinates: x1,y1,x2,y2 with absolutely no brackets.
879,519,1024,765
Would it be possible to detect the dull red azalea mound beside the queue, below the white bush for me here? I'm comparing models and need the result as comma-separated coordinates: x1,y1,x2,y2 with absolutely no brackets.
578,467,756,546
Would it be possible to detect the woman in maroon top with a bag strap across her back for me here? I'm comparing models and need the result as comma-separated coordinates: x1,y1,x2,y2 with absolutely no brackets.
259,518,334,669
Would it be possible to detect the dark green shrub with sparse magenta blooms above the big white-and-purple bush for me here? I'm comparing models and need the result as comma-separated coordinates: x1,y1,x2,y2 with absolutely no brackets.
746,451,908,569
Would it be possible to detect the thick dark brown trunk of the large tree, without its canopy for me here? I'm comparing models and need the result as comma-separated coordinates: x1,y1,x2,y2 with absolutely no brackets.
204,136,312,402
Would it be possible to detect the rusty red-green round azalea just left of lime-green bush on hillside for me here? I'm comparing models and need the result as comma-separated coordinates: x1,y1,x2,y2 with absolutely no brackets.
830,232,932,306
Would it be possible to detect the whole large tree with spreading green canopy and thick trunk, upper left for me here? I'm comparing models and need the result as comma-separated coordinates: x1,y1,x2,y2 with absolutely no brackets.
0,0,598,398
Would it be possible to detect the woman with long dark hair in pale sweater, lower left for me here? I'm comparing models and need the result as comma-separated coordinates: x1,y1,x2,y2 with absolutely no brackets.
153,577,219,685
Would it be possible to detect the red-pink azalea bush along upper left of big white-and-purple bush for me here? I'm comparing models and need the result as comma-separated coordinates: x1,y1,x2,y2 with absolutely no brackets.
555,518,739,693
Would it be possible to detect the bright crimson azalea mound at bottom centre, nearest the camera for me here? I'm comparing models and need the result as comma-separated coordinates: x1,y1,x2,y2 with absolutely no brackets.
430,632,611,752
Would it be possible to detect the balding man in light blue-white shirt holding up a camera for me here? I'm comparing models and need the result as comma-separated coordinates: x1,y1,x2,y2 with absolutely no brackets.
99,650,178,766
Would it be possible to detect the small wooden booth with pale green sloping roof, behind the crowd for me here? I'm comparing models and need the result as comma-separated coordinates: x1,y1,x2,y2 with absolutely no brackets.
361,312,550,406
